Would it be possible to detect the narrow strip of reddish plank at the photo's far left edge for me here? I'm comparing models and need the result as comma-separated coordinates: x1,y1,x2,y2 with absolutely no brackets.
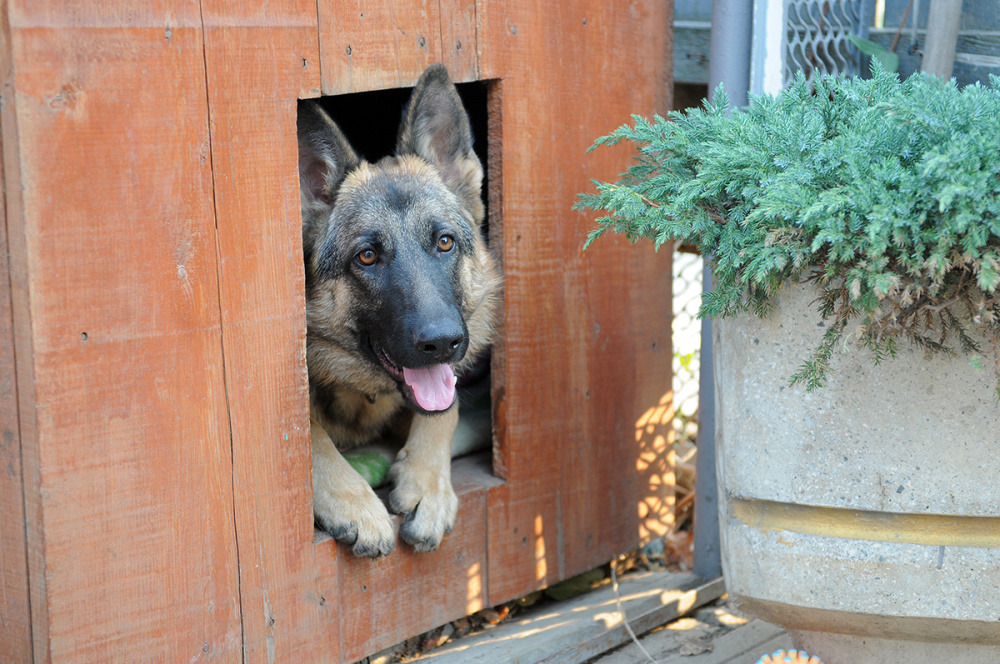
0,3,32,662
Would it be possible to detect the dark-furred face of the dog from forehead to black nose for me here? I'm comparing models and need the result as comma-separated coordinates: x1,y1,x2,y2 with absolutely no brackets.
314,158,476,377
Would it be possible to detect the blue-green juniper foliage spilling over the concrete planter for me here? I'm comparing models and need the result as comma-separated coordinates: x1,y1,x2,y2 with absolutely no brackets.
576,66,1000,395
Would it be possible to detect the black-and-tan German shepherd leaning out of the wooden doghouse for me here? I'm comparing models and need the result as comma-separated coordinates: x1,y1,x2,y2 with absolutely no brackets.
298,65,501,557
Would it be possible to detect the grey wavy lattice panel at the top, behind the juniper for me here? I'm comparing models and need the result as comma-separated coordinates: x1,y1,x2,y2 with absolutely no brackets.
784,0,861,86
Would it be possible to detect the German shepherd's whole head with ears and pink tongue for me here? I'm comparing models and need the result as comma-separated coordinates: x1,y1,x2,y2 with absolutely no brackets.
298,65,497,412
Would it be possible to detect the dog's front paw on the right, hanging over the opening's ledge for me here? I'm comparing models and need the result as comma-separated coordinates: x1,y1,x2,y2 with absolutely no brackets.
389,457,458,551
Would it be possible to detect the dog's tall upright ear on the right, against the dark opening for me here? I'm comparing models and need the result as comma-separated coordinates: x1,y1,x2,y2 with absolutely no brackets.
396,64,483,221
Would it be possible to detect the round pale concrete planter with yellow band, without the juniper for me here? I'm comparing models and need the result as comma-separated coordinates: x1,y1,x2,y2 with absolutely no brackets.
714,285,1000,664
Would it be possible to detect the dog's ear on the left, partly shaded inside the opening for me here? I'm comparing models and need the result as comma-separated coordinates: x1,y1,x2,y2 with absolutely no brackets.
298,102,361,205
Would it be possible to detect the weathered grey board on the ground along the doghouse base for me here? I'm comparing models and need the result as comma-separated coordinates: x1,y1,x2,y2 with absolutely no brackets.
420,572,725,664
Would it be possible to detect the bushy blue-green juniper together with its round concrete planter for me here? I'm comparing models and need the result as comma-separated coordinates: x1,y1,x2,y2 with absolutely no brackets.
578,67,1000,664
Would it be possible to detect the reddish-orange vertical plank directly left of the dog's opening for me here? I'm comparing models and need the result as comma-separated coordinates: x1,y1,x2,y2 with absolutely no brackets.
202,0,341,662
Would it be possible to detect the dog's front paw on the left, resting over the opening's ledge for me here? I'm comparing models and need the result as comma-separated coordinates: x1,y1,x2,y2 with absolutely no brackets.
313,477,396,558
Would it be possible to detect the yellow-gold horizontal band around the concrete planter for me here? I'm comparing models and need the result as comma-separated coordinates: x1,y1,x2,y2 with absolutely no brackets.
727,496,1000,548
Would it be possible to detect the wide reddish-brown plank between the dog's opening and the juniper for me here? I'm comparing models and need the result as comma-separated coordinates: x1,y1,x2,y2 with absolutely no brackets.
476,0,671,603
